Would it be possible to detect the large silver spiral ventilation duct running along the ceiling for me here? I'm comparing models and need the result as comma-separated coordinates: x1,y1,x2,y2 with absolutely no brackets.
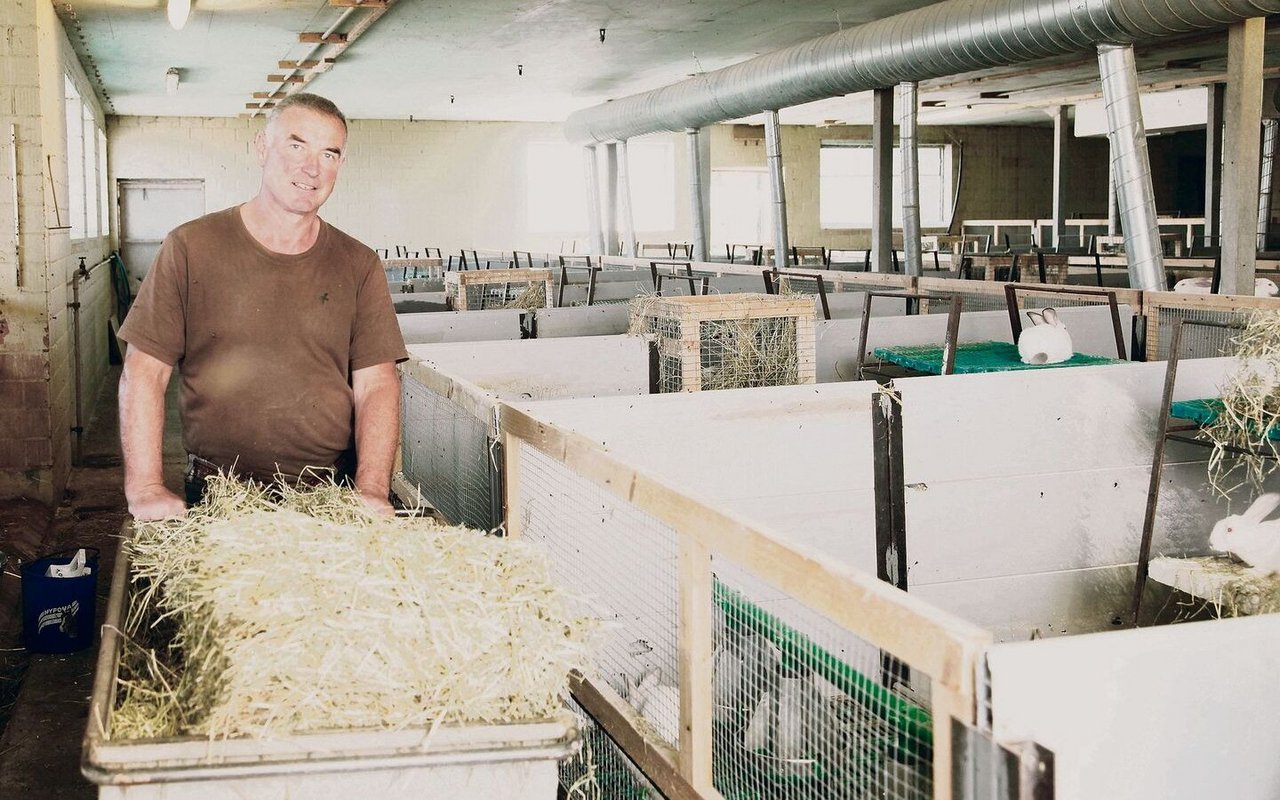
564,0,1280,145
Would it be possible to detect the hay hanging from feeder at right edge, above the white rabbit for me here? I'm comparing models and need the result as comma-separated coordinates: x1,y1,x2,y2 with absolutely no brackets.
1203,310,1280,497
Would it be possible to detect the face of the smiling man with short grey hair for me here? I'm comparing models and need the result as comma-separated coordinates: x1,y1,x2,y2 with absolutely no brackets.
257,106,347,214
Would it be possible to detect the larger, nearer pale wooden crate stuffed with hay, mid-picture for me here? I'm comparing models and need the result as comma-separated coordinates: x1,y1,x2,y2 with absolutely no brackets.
631,294,817,392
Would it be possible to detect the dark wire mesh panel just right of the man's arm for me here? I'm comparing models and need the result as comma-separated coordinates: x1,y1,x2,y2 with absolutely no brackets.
401,375,502,530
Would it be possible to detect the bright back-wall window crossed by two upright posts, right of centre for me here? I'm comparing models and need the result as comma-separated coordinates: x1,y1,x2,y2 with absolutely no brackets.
818,142,951,228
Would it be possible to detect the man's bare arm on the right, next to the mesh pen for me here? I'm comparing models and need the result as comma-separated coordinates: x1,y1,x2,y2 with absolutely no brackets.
351,362,399,515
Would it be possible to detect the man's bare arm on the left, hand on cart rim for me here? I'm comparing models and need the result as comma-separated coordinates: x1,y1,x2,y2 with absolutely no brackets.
120,347,187,520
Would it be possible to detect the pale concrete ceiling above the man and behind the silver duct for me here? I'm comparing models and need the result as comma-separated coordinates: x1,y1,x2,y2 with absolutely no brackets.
55,0,1276,124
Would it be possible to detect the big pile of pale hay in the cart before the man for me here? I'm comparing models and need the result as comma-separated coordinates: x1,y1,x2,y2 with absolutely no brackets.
108,477,591,739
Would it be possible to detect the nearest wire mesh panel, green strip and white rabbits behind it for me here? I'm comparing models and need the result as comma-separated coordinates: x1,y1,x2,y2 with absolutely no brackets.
712,558,933,800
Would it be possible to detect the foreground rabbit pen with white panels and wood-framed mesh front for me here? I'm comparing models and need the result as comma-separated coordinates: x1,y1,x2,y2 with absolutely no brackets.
499,358,1280,800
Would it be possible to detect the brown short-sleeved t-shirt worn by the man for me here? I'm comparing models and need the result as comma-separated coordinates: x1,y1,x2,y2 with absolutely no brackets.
119,206,407,475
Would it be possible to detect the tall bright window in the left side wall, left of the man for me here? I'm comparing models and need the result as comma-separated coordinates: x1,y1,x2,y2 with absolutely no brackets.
58,76,109,239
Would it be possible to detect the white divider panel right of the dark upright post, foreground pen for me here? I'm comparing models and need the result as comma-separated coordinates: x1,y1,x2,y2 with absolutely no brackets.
895,358,1264,640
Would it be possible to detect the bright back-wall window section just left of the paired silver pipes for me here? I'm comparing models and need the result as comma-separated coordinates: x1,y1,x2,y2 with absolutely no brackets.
525,142,588,233
